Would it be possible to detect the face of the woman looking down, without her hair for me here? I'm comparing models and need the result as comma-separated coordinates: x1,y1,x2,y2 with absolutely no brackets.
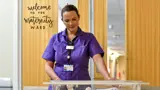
63,11,79,32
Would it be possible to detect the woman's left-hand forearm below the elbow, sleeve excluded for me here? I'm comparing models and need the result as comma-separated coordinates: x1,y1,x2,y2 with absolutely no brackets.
45,64,59,80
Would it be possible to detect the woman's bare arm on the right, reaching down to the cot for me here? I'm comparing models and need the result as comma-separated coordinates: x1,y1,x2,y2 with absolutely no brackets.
93,54,111,80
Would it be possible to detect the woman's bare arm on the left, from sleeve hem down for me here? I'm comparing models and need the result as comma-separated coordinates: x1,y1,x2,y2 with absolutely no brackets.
45,60,60,80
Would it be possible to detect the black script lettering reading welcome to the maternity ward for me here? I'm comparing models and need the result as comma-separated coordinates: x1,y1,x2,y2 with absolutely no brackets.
23,3,54,30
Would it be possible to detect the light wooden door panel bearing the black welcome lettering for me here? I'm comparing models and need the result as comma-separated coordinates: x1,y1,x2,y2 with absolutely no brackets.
22,0,58,86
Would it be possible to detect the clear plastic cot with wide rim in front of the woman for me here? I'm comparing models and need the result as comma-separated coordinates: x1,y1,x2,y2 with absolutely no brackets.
44,80,149,90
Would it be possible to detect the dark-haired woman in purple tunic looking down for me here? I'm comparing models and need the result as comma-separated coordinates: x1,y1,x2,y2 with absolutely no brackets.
42,5,110,90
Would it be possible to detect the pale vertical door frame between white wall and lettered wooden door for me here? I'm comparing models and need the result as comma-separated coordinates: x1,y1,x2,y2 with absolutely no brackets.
12,0,22,90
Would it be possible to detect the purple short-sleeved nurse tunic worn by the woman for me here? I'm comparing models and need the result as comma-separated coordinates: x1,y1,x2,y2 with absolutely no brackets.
42,28,104,89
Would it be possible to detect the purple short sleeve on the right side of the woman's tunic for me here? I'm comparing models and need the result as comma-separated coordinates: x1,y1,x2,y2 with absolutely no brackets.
89,34,104,57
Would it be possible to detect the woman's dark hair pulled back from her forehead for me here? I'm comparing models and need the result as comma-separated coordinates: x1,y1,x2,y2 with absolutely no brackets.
61,4,80,19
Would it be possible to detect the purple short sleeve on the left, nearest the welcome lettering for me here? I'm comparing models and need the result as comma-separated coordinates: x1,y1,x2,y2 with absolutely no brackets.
42,36,55,62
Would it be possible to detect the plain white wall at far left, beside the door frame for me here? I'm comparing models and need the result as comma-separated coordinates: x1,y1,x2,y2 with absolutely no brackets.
0,0,14,78
